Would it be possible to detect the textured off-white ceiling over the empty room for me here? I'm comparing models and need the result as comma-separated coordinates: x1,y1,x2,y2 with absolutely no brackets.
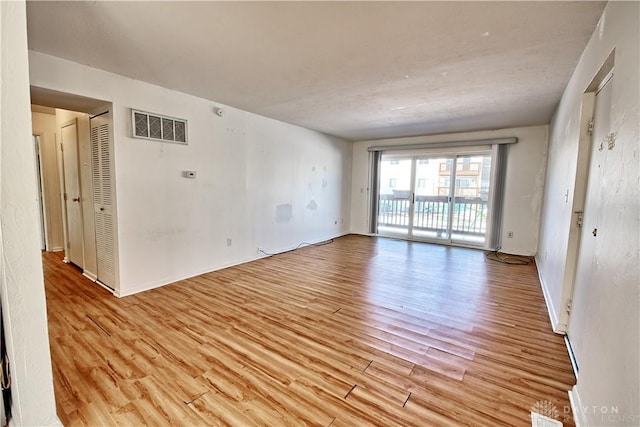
27,1,604,140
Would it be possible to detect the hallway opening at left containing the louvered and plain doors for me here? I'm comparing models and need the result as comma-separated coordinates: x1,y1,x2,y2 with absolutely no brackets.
31,87,118,292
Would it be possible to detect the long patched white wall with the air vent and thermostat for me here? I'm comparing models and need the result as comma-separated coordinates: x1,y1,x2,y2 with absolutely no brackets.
30,52,351,295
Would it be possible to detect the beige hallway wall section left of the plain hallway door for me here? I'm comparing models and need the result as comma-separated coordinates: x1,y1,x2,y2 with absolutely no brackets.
31,112,64,251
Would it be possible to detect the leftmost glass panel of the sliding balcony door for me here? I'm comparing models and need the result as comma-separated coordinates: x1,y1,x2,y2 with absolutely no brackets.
378,155,413,237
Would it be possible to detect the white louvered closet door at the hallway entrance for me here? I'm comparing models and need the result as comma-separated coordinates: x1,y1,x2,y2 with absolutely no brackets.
91,114,116,289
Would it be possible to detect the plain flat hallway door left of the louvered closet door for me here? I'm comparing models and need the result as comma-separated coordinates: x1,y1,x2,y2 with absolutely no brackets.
60,120,83,267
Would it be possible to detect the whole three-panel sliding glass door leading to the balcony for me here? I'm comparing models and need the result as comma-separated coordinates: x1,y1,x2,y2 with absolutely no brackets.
377,153,491,246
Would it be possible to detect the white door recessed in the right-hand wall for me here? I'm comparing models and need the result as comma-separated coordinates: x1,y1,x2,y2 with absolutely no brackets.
567,73,613,369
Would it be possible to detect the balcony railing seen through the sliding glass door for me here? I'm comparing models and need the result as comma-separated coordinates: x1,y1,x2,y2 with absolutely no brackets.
378,192,487,236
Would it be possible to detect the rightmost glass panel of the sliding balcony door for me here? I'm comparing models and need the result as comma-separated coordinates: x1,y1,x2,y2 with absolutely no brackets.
451,154,491,246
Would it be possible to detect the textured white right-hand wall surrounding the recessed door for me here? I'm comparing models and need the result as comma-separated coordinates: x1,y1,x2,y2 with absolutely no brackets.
538,2,640,425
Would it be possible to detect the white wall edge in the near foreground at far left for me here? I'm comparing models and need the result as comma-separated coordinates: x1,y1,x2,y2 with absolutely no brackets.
0,1,60,426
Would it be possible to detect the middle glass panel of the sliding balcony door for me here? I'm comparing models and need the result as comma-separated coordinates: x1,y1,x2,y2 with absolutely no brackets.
412,157,454,240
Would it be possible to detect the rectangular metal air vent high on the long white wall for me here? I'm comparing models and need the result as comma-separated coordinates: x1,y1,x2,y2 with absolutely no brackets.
131,108,187,145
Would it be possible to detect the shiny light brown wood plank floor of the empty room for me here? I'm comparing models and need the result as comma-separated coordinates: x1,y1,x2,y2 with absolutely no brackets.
43,236,575,427
